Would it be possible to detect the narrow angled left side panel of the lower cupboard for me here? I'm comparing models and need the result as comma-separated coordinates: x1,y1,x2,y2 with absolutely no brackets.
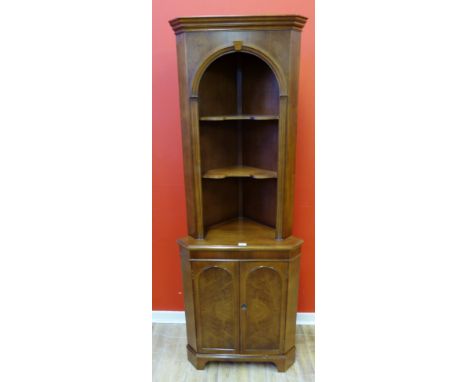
180,248,197,350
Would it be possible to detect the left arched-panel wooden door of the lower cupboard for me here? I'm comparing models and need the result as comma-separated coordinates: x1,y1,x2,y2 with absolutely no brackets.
192,261,239,353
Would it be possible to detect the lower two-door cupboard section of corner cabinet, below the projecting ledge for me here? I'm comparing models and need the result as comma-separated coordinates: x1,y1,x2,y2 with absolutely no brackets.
181,254,299,371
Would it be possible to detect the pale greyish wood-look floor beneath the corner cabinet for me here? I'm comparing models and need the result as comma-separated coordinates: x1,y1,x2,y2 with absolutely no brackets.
153,324,315,382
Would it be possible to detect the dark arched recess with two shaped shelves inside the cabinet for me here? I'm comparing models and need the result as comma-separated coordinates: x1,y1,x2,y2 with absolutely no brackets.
198,52,280,229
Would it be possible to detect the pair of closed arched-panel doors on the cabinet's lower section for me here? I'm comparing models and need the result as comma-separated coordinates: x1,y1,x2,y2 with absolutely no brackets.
192,261,288,354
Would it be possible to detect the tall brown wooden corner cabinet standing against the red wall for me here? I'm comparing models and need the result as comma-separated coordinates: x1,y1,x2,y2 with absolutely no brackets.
170,15,306,371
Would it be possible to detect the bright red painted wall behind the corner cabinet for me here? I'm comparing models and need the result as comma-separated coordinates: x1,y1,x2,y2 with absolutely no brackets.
153,0,315,312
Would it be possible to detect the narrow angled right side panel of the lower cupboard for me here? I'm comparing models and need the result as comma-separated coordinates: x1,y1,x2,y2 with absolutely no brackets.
284,256,301,352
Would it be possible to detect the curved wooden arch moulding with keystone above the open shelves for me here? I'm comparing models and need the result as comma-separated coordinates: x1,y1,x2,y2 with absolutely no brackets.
191,42,287,97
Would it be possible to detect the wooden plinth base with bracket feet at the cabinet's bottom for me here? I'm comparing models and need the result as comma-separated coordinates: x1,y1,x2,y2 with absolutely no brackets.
187,345,296,372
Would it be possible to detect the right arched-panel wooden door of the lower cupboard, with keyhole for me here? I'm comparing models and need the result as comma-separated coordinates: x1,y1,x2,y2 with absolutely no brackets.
240,261,288,354
